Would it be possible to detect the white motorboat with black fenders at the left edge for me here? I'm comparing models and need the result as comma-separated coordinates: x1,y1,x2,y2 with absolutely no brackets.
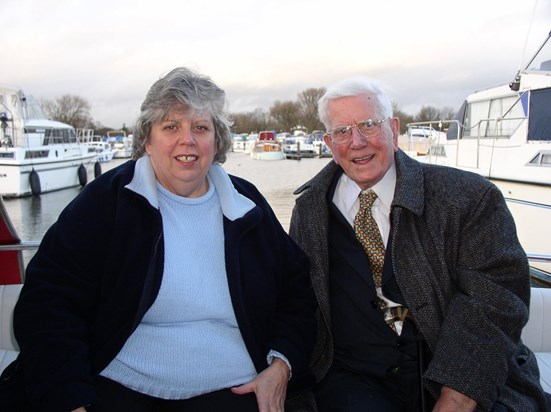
0,87,97,197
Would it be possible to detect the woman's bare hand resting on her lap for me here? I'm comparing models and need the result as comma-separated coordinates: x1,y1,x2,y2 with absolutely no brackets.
231,358,290,412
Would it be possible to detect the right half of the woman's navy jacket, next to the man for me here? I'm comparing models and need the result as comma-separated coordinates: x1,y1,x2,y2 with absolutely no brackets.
232,181,316,387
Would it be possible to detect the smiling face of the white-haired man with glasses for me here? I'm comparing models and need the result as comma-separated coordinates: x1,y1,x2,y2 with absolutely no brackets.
324,93,400,190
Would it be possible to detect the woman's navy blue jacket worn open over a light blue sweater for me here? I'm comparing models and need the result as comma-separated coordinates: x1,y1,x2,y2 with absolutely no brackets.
14,161,315,411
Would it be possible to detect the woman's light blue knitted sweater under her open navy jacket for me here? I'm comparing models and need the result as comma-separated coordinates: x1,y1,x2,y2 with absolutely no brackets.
102,177,256,399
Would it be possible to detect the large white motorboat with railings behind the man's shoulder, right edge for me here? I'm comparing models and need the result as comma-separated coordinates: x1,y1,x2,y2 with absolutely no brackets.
402,33,551,274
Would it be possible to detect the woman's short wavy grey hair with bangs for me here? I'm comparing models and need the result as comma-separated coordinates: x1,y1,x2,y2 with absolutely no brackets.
132,67,232,163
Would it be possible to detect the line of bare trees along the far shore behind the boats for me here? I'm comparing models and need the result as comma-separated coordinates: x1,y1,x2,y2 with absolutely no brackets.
42,87,455,135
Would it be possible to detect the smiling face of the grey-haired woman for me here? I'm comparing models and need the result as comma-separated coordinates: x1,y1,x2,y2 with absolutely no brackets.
145,105,217,197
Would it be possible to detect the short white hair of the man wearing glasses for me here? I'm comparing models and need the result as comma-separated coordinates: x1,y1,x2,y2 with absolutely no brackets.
318,77,393,131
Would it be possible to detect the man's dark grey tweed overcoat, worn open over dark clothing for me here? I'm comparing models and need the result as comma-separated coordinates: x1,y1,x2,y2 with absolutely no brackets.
290,150,545,411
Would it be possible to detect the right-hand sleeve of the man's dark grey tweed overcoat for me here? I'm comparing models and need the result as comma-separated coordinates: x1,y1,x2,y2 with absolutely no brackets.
425,185,530,410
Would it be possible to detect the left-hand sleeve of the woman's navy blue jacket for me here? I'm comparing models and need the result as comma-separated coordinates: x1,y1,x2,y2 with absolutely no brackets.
14,187,107,411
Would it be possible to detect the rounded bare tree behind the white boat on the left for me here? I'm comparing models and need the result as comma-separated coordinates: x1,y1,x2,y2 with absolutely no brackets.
42,94,93,129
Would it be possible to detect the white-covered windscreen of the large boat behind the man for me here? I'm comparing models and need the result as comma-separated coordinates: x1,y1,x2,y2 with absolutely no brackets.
463,95,526,138
